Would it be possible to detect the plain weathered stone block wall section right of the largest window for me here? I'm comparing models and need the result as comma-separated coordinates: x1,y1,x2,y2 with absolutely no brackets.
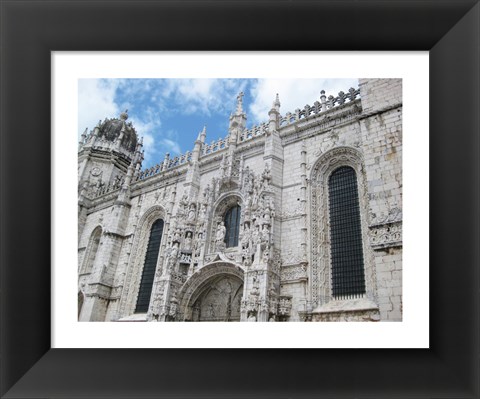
360,79,403,321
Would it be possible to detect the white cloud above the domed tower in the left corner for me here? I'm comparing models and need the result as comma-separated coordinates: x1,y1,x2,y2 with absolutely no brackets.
78,79,121,137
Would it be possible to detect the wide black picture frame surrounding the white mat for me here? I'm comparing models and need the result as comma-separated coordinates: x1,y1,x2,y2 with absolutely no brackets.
0,0,480,398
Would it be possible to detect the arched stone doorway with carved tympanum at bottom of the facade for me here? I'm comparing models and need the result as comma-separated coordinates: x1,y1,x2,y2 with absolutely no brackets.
178,261,244,321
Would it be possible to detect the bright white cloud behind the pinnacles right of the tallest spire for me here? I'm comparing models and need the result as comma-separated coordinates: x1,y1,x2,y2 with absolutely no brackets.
248,79,358,124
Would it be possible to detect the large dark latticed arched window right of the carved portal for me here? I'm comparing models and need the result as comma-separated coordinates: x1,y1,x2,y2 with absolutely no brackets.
328,166,365,298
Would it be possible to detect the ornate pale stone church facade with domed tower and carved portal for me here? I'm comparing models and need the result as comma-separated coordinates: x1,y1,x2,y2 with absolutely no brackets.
78,79,402,322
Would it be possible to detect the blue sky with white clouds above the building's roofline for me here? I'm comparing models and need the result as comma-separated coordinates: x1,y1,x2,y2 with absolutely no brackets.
78,79,358,168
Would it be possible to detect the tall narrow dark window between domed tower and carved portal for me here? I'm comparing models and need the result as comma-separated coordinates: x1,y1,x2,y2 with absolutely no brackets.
135,219,163,313
